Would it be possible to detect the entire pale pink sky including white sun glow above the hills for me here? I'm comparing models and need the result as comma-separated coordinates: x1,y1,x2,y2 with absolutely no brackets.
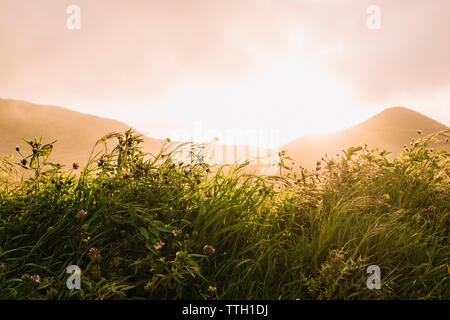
0,0,450,146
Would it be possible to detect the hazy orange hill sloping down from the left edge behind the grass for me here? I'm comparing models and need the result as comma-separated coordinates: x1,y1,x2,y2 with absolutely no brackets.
0,99,161,166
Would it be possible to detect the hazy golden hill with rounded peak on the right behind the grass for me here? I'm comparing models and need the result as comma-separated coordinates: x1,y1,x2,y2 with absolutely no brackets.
281,107,448,169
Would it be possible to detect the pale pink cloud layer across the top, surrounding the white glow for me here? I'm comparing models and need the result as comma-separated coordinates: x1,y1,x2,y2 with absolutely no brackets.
0,0,450,124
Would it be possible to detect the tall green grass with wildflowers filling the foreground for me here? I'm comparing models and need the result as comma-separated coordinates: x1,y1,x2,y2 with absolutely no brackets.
0,130,450,299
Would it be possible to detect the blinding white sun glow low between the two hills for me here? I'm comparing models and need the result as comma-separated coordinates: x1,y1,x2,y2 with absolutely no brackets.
146,39,365,147
